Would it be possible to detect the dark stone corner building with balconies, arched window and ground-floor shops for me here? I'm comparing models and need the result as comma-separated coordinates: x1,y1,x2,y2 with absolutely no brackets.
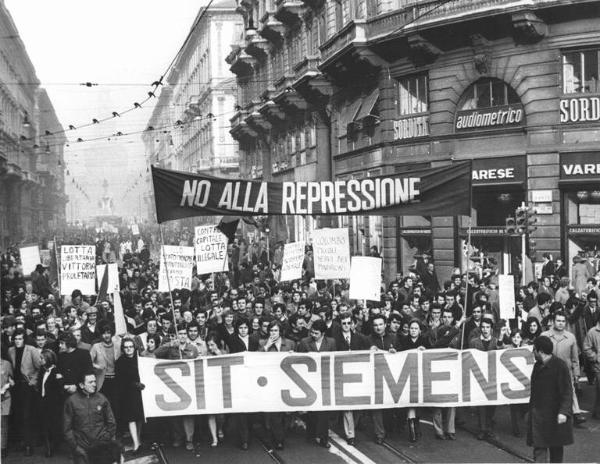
228,0,600,278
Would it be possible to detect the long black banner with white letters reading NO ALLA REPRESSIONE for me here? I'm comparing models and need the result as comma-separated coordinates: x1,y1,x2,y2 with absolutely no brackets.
152,161,471,223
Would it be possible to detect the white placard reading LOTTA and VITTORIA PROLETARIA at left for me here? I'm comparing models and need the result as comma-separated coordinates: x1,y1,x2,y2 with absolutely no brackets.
60,245,96,295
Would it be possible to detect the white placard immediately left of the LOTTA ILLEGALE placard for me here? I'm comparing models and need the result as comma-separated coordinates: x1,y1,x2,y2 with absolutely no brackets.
158,245,194,292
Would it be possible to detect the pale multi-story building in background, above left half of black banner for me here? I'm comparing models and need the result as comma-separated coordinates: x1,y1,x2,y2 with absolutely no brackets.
143,0,242,221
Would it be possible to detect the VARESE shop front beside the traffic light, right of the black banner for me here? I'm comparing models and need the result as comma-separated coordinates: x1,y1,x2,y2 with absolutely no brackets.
458,156,527,273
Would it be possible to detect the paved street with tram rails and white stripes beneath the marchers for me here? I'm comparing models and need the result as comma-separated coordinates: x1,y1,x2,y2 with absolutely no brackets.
3,378,600,464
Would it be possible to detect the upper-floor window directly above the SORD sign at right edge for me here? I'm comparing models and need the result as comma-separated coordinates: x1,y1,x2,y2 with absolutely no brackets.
562,49,600,93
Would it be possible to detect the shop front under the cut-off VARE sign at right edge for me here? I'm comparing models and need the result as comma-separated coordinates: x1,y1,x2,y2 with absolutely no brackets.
559,152,600,273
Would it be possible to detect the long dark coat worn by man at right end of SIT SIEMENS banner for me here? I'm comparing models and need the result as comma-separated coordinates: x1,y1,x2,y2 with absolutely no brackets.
527,356,573,448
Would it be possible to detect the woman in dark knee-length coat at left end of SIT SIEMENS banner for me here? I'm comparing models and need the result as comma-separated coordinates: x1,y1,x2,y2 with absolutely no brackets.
115,338,144,455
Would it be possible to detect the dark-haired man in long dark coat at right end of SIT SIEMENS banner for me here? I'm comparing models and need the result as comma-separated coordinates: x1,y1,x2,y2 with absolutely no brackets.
527,335,573,462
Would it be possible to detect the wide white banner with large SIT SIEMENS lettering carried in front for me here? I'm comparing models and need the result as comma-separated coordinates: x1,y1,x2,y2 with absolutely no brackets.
138,348,534,417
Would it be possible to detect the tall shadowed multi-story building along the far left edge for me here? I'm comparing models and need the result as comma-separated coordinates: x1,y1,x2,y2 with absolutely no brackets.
0,2,66,246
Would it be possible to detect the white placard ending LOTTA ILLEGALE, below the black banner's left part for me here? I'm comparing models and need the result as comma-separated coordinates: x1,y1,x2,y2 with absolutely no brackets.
194,226,227,275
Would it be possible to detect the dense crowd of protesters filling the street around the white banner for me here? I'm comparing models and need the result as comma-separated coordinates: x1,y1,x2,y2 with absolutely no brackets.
0,231,600,462
